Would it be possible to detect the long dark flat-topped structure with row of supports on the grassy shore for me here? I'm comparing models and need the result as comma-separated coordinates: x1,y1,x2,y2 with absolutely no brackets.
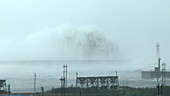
76,76,119,89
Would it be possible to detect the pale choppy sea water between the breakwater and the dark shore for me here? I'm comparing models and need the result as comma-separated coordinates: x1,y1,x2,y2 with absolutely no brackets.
0,60,165,92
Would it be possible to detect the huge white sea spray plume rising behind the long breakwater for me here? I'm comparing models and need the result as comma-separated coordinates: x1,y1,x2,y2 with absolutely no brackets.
0,25,118,60
